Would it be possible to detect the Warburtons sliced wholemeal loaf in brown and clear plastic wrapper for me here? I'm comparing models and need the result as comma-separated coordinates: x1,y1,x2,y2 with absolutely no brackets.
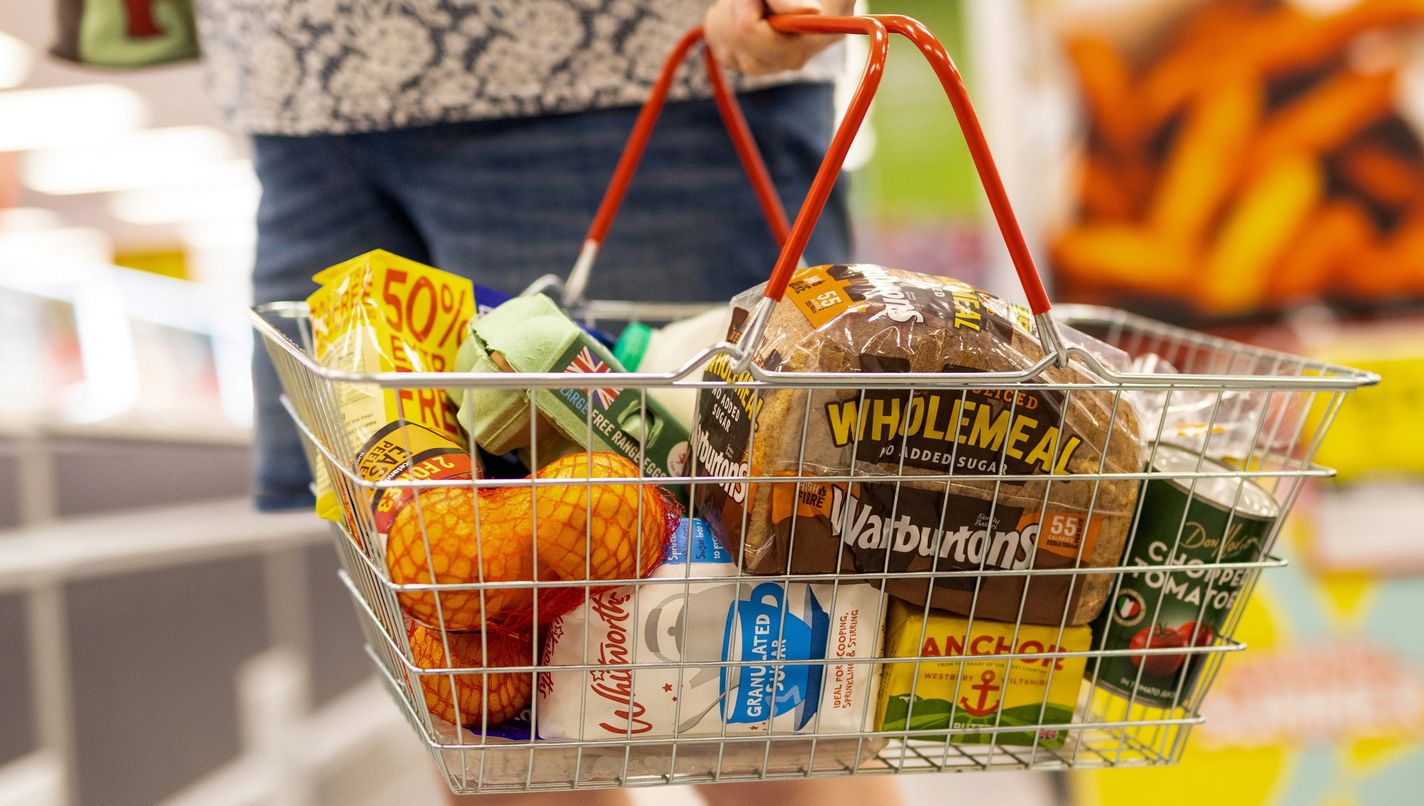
695,265,1143,624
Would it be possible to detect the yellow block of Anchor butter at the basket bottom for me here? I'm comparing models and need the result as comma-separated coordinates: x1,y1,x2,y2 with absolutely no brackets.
876,600,1092,748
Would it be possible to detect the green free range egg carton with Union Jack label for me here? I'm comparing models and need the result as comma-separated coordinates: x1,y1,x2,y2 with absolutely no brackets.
450,295,689,497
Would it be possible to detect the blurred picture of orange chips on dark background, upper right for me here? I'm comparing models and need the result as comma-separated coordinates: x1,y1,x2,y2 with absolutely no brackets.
1053,0,1424,318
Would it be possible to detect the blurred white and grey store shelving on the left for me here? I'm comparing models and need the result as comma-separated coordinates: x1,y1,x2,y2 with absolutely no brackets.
0,251,430,806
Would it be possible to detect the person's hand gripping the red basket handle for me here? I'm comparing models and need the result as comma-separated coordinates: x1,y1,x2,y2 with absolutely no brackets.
702,0,856,75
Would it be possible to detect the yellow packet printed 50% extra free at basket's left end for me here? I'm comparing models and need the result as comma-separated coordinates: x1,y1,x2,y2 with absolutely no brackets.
306,249,474,535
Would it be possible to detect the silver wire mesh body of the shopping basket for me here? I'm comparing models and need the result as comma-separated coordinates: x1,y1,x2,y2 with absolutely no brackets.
253,303,1373,793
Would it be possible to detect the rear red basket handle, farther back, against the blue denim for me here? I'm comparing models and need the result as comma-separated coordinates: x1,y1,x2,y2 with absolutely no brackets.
564,27,790,305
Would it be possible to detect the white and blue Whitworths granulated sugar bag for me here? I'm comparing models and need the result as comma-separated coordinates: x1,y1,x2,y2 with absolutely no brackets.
537,518,884,740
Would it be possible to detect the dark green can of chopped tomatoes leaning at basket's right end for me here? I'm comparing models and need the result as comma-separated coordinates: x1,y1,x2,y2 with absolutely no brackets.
1089,446,1280,708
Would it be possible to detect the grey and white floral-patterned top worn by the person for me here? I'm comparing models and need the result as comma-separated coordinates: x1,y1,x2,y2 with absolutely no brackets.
197,0,844,134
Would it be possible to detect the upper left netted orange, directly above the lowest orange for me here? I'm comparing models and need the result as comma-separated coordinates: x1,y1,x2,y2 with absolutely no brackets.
386,487,534,631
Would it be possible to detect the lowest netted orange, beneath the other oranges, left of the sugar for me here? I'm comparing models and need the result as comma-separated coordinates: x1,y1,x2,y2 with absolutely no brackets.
409,624,534,731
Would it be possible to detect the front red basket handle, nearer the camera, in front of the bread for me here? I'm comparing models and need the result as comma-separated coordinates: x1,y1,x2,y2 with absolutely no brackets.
723,14,1068,369
